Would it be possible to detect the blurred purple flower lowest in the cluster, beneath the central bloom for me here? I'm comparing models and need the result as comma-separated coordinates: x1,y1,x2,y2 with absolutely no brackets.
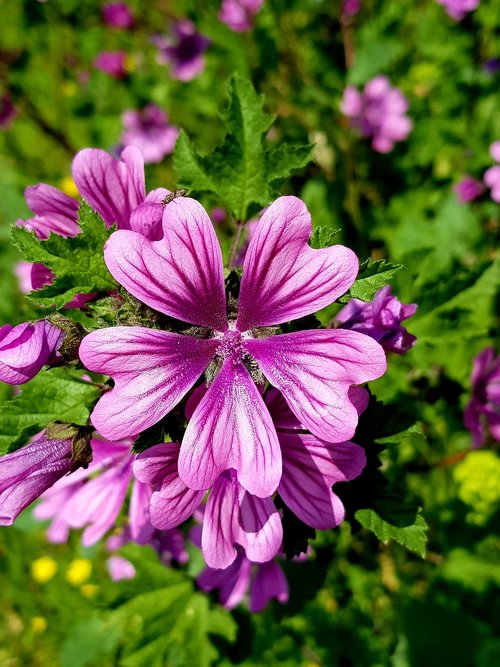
196,551,288,613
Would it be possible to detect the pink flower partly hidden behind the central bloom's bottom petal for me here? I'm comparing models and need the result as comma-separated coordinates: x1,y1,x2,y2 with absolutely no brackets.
134,387,368,568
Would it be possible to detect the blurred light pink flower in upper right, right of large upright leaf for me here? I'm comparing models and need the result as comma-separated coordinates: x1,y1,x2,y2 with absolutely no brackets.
340,76,413,153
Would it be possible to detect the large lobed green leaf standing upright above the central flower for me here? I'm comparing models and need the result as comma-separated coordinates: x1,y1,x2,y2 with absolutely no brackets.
174,75,312,221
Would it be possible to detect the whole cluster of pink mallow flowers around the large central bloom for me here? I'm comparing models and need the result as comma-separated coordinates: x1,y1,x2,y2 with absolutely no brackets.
0,142,426,610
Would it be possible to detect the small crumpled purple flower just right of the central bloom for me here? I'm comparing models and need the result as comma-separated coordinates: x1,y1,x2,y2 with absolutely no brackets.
335,285,417,354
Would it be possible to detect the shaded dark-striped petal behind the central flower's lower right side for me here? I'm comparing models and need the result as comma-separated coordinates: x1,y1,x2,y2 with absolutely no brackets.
278,433,366,530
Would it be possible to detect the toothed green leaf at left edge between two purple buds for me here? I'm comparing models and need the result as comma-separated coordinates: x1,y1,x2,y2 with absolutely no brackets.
0,368,100,454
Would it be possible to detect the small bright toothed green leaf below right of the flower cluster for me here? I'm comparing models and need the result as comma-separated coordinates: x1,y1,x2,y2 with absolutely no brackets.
354,501,427,558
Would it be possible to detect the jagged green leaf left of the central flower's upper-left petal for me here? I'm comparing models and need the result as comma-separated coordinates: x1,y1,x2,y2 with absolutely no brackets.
12,202,117,308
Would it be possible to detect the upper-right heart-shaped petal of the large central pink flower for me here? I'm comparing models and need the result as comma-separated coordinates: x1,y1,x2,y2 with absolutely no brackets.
237,197,358,331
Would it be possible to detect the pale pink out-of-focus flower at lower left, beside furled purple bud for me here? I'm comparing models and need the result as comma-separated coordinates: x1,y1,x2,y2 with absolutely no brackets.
35,438,154,546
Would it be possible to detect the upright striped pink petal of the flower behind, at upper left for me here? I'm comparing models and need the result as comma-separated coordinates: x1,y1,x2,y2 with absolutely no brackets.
73,146,146,229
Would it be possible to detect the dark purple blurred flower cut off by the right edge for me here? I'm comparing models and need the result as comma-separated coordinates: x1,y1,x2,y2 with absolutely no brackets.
464,347,500,448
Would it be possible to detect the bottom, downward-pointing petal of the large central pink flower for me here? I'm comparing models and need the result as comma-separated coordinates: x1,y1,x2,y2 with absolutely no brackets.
179,359,281,498
